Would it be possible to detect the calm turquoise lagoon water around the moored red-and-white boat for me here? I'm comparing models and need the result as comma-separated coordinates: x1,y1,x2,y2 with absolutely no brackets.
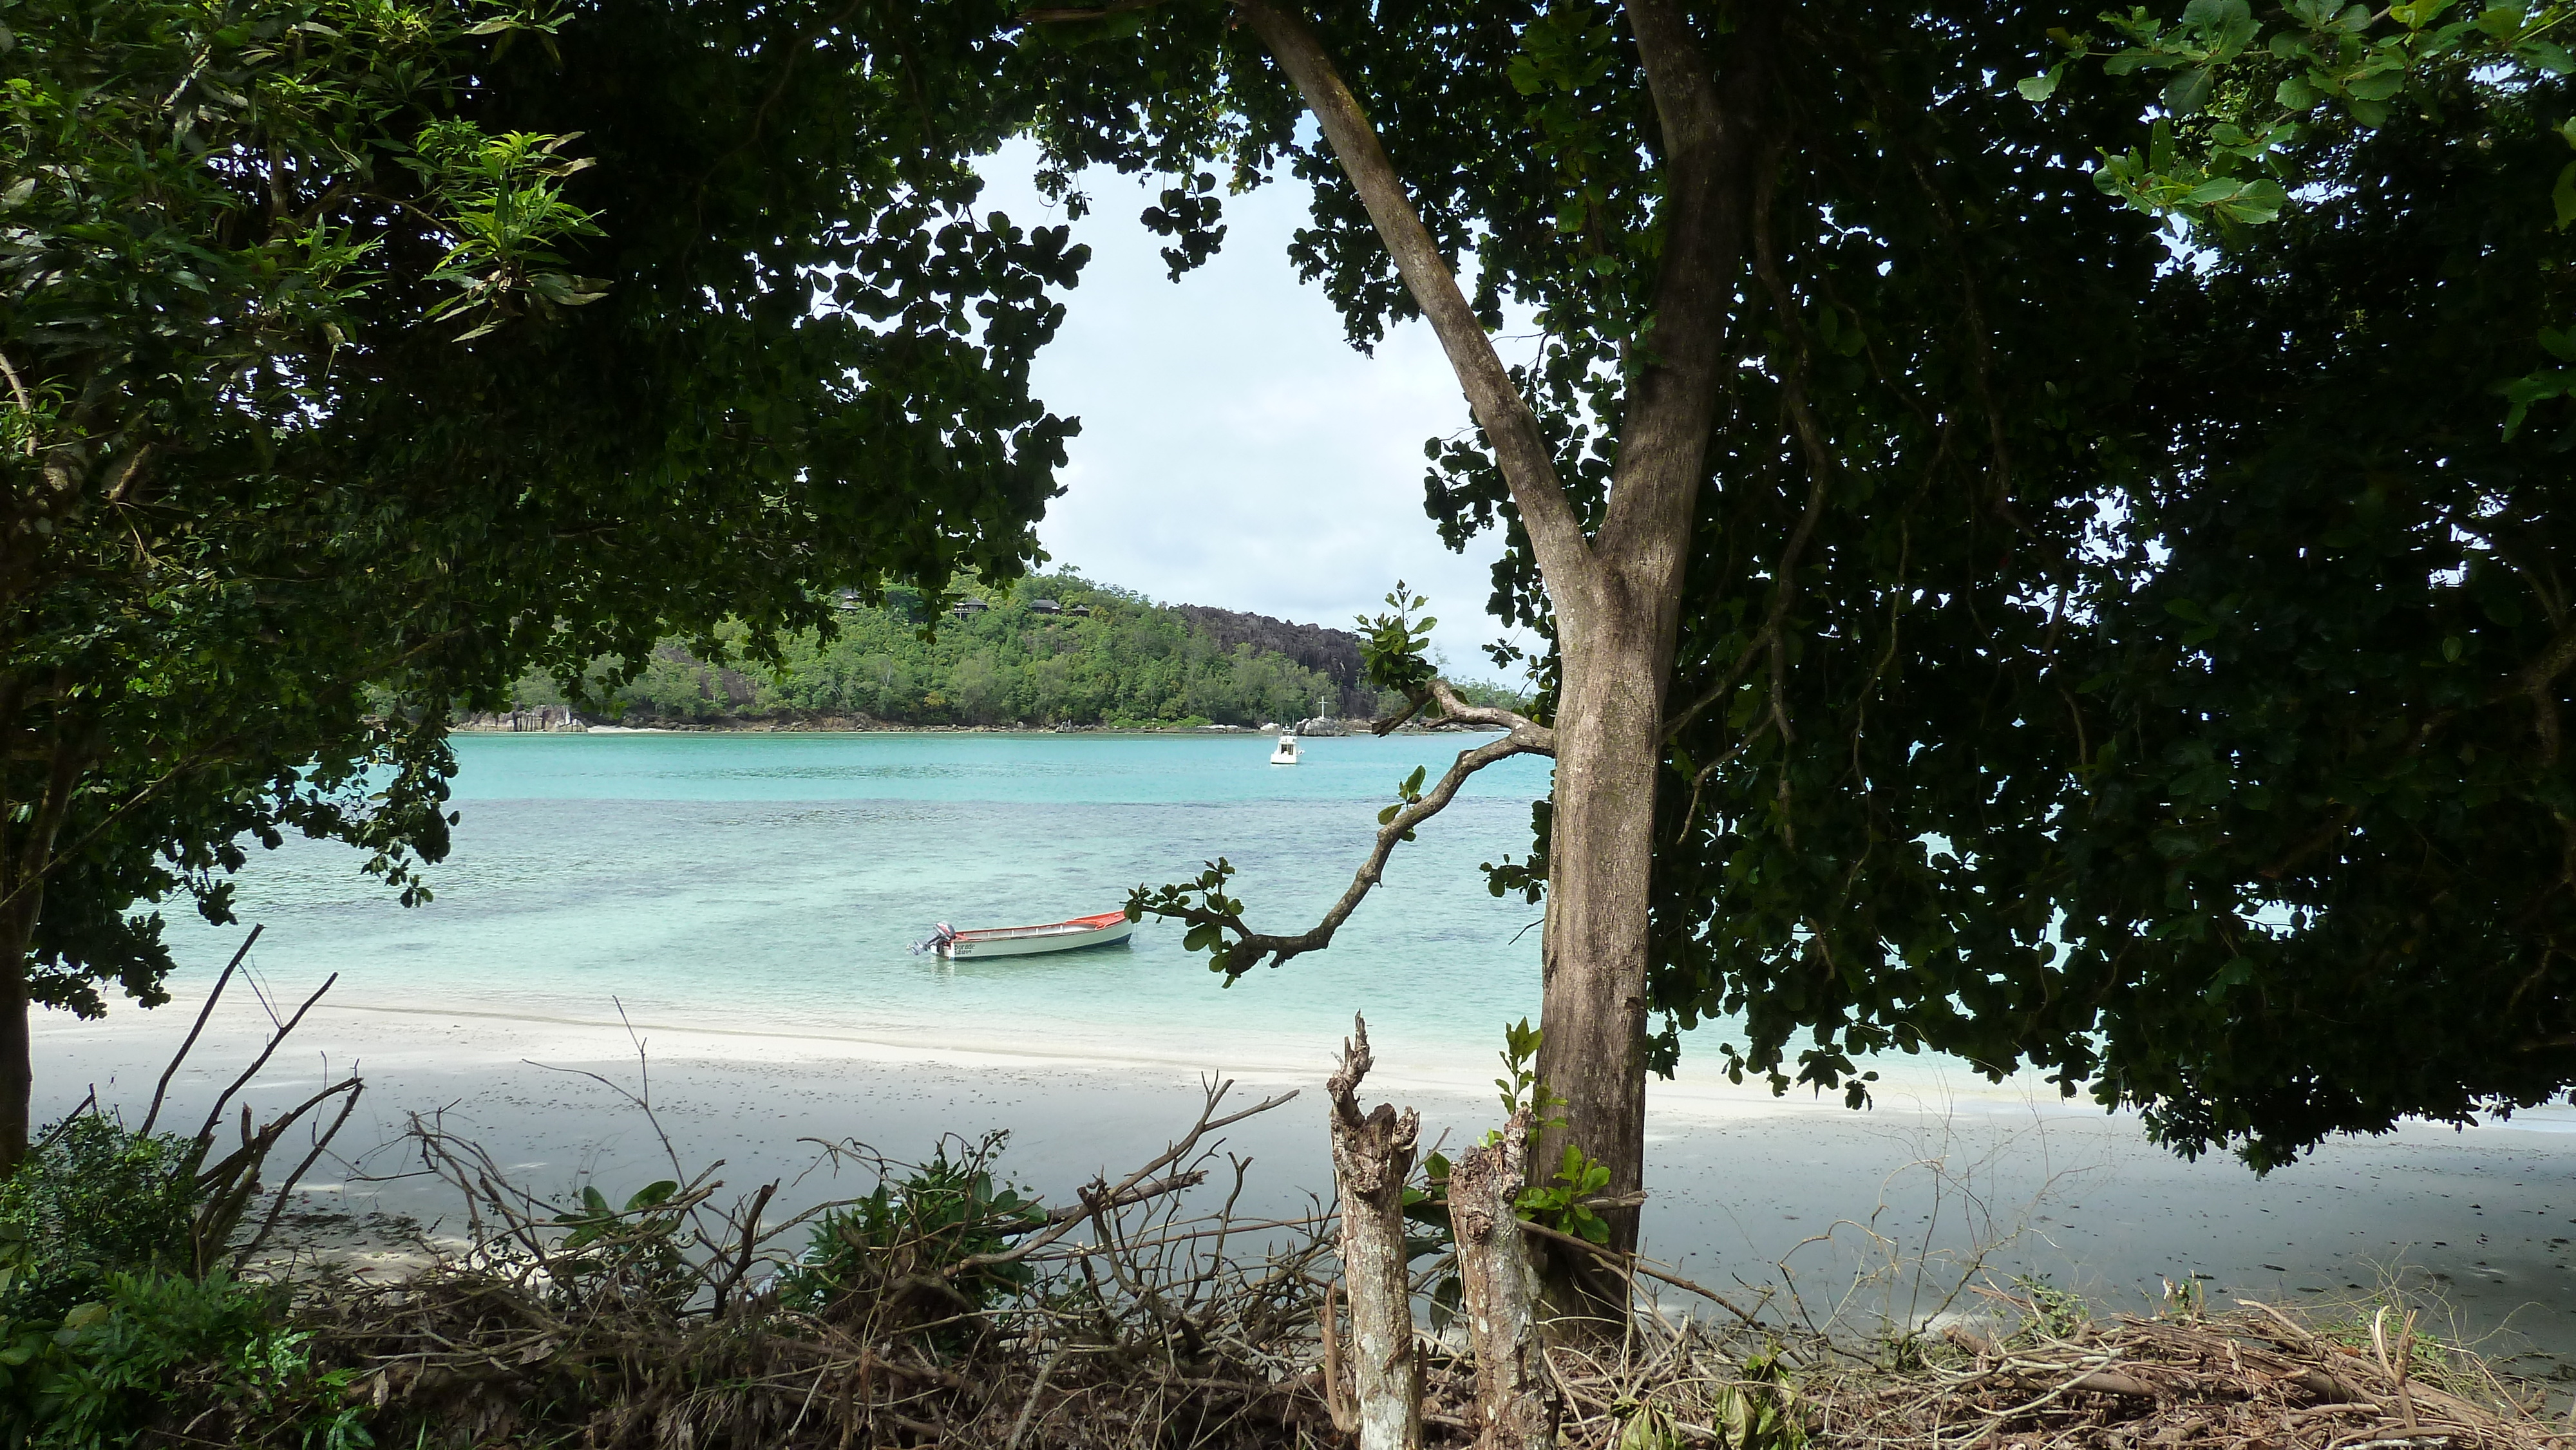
183,734,1548,1066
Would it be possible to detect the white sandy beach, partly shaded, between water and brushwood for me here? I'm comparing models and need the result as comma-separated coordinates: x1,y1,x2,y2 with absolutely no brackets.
36,986,2576,1375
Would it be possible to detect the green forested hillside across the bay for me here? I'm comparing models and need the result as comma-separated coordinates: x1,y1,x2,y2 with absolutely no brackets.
518,572,1515,729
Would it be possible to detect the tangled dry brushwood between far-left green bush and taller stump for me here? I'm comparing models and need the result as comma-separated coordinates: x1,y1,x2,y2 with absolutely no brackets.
290,1084,1329,1447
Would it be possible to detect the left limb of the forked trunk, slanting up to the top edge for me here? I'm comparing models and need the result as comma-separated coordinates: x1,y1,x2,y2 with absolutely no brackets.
1236,0,1592,587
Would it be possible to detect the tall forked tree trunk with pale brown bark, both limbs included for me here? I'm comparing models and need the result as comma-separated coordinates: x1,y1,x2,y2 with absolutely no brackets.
1236,0,1780,1313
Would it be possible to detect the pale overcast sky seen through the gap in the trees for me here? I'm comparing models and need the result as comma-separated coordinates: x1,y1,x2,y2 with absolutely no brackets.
979,147,1530,680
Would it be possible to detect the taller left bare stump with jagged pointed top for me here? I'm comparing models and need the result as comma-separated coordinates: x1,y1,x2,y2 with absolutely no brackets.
1324,1017,1422,1450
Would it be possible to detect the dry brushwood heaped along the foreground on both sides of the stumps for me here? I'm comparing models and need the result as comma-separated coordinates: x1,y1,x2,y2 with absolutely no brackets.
256,1169,2571,1450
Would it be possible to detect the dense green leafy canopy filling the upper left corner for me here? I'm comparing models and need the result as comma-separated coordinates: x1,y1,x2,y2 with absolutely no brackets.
0,0,1082,1164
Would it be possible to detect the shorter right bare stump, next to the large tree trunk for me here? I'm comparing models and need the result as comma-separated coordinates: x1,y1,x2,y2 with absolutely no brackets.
1448,1110,1556,1450
